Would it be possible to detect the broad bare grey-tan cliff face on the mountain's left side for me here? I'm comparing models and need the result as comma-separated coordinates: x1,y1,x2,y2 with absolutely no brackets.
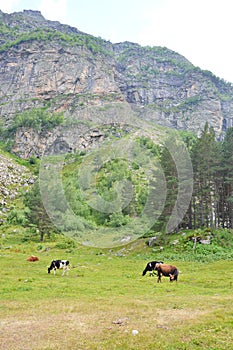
1,41,121,117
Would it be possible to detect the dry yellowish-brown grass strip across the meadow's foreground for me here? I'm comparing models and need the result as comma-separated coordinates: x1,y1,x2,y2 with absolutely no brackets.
0,301,208,350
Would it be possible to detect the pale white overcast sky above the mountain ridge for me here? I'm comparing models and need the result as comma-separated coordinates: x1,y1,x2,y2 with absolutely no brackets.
0,0,233,83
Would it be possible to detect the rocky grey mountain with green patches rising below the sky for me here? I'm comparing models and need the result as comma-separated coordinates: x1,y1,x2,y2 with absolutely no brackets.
0,10,233,158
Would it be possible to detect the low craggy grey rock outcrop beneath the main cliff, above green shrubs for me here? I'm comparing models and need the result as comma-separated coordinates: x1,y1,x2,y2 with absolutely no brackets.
12,123,131,158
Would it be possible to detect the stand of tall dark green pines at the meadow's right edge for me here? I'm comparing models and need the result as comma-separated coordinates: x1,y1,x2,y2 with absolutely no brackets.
159,124,233,229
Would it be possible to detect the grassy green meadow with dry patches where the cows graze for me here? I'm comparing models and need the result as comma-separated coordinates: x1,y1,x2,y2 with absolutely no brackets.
0,231,233,350
